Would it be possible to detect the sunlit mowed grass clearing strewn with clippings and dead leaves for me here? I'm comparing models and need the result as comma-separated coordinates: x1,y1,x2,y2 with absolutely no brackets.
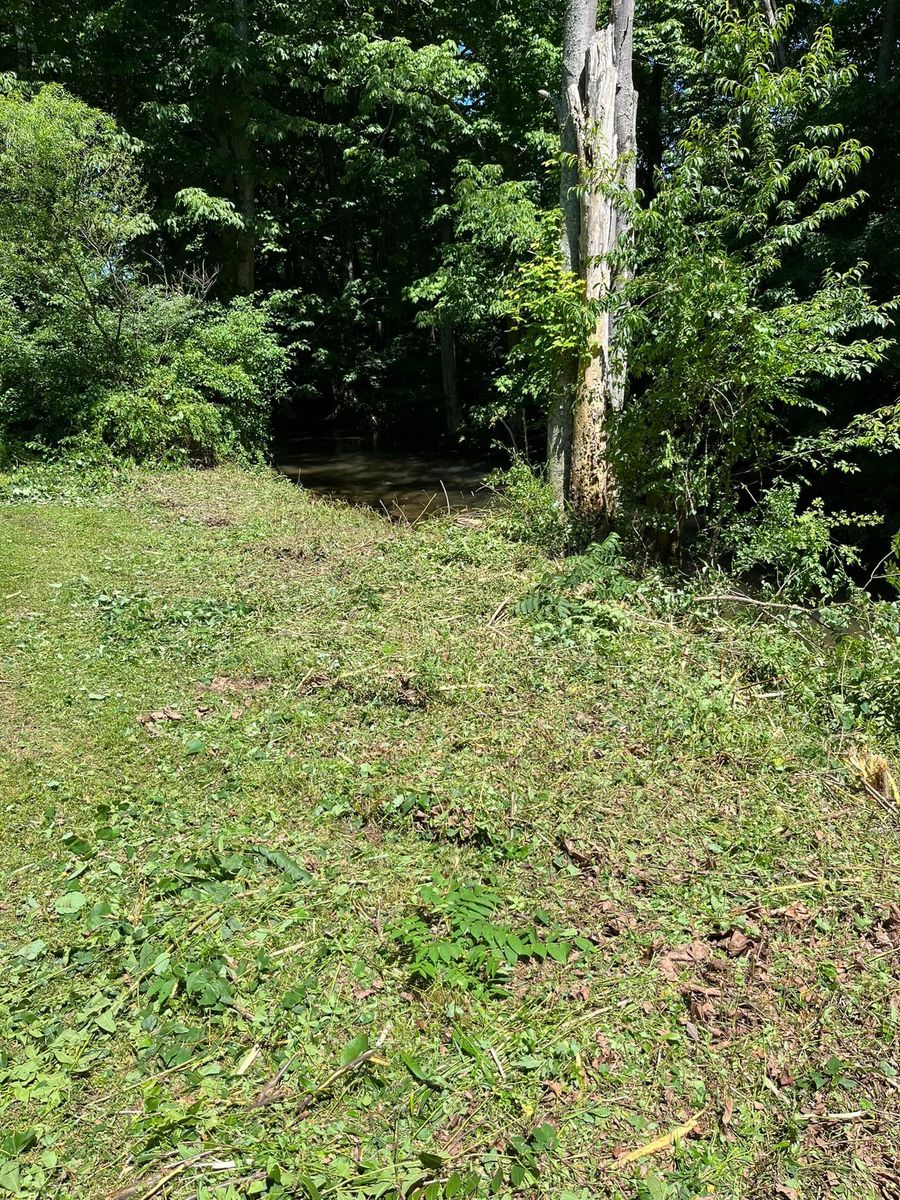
0,469,900,1200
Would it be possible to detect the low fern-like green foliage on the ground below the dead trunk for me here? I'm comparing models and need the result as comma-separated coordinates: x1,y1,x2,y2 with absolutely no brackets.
512,533,637,643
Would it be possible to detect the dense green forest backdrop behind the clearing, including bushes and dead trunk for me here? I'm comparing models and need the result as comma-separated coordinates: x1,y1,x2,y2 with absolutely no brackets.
0,0,900,575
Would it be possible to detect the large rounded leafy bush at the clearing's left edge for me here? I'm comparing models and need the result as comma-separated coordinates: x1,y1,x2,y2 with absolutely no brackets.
0,82,287,463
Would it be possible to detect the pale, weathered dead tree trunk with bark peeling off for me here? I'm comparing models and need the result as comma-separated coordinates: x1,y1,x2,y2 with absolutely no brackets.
547,0,637,523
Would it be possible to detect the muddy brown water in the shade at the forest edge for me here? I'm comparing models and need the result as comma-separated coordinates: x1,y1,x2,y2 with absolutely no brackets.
276,439,492,522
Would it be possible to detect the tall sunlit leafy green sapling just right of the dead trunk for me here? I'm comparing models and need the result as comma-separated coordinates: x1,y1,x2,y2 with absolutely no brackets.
617,4,889,540
